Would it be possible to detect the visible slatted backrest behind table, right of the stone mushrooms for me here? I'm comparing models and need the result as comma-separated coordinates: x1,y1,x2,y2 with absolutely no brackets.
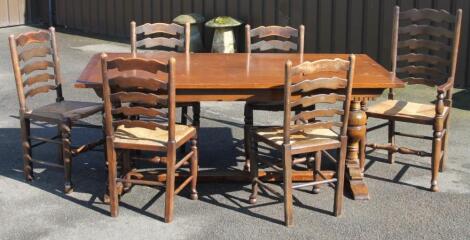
245,24,305,53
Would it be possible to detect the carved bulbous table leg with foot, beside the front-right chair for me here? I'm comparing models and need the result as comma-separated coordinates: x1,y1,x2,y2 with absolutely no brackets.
346,100,369,200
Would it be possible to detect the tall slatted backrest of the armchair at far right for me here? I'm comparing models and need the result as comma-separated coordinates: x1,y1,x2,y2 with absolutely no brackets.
390,6,462,90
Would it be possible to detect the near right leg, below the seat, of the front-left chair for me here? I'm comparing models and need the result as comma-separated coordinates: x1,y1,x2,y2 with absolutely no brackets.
165,145,176,223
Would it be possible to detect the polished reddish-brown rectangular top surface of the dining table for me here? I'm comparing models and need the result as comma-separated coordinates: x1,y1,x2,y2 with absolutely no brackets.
75,52,404,90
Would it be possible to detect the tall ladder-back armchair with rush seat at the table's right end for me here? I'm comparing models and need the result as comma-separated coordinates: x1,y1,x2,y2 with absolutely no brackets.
361,6,462,191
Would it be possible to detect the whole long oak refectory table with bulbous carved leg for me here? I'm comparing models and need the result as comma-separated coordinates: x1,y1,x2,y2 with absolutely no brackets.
75,52,404,199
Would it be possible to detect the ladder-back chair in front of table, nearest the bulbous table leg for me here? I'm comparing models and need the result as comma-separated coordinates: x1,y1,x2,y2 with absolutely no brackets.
250,55,355,226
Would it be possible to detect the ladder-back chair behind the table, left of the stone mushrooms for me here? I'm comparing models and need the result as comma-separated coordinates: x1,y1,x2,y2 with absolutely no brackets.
131,21,201,127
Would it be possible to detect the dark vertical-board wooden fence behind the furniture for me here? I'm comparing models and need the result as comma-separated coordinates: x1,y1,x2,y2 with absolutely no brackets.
50,0,470,88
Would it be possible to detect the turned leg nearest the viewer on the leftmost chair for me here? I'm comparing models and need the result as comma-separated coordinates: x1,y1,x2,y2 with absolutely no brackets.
59,122,73,193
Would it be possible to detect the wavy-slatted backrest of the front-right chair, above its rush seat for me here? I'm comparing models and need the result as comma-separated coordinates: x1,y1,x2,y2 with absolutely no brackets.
284,55,356,144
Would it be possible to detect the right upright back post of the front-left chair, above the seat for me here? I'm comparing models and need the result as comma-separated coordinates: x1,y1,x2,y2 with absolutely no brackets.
168,57,176,143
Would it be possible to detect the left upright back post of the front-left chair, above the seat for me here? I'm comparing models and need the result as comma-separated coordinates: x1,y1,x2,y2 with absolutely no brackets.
101,53,114,137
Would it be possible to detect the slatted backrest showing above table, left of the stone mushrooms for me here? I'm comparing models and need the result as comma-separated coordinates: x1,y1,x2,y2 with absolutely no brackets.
130,22,191,56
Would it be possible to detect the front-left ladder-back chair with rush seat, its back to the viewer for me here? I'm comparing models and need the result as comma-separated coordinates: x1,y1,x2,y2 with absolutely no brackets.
101,54,198,222
